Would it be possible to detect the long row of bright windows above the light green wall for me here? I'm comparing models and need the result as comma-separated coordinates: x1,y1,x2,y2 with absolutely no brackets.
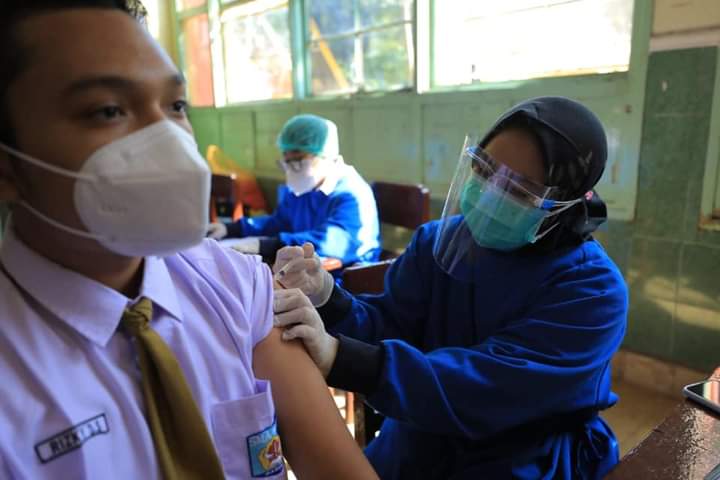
175,0,644,101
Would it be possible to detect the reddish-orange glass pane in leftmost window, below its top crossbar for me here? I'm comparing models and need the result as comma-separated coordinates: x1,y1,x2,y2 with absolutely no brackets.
181,14,215,106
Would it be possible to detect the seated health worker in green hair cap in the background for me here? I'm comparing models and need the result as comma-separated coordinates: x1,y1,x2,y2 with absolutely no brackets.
209,115,380,265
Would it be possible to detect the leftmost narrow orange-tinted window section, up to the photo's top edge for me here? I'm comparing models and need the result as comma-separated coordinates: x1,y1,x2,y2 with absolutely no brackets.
176,0,215,107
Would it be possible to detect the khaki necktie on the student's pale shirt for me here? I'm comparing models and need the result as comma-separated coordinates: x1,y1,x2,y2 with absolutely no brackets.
122,298,224,480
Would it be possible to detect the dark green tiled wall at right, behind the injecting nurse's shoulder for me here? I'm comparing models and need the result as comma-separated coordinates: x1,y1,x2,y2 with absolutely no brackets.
599,48,720,371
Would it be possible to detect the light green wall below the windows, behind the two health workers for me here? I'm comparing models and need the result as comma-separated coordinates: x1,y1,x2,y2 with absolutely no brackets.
191,71,645,220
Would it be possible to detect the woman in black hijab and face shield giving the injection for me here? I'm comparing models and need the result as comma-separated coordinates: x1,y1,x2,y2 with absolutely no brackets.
274,97,628,479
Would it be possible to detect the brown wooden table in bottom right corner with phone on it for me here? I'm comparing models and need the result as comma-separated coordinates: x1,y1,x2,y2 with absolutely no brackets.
605,367,720,480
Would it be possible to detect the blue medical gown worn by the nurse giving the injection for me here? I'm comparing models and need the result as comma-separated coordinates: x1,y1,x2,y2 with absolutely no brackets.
323,223,628,479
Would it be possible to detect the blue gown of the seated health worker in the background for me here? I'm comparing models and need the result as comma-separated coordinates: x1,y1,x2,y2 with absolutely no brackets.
235,165,380,265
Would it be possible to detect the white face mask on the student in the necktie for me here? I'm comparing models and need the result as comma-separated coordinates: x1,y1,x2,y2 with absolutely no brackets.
0,120,210,257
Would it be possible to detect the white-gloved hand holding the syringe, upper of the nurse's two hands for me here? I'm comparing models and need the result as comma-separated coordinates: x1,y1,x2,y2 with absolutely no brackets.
273,243,335,307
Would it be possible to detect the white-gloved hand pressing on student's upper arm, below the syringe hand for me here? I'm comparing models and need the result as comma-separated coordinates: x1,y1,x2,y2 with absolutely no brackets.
273,288,340,377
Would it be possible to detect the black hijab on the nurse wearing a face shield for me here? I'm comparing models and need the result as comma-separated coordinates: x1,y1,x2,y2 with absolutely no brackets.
480,97,607,255
